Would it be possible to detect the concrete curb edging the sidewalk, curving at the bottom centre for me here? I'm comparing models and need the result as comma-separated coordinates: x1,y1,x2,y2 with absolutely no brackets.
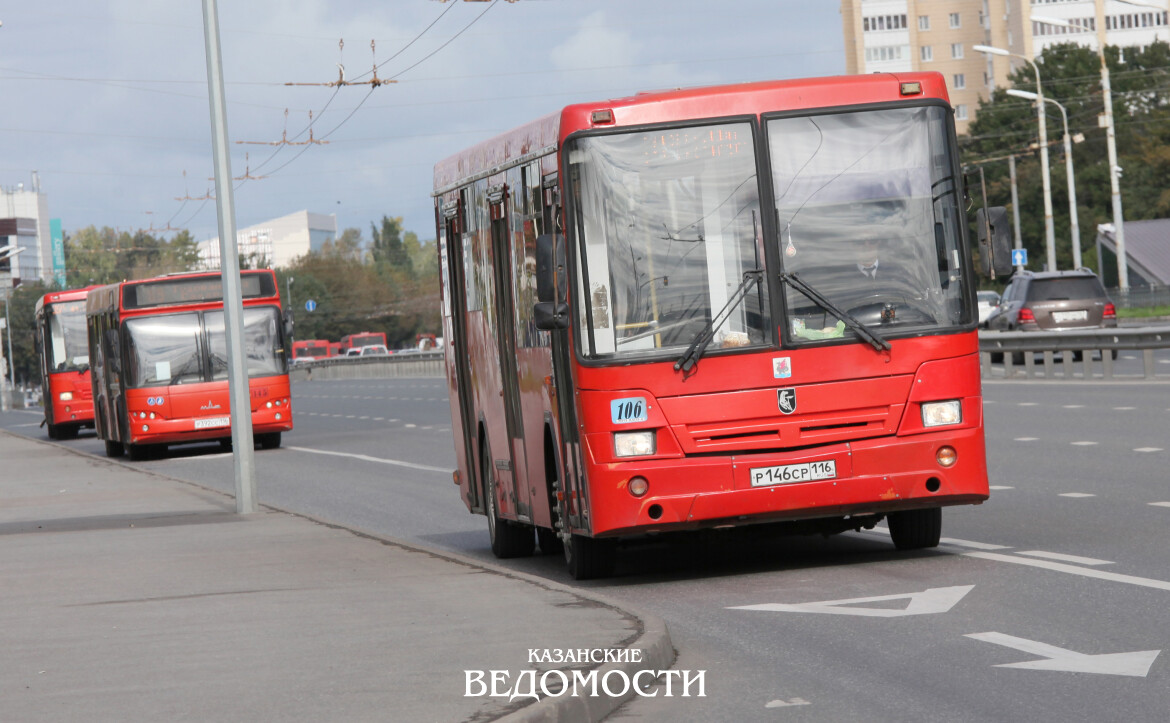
0,429,676,723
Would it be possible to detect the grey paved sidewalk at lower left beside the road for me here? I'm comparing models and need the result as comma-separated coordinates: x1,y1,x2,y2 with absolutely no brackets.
0,432,674,722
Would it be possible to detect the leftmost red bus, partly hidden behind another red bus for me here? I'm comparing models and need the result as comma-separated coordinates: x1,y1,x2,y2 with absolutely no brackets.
34,287,95,440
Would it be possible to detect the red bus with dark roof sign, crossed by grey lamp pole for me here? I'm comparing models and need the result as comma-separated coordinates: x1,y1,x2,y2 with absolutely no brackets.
87,269,293,460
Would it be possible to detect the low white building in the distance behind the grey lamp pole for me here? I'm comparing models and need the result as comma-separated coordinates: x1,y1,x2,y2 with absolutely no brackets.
199,211,337,269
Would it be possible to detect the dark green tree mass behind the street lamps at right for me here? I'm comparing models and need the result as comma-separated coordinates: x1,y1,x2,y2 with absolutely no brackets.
959,41,1170,276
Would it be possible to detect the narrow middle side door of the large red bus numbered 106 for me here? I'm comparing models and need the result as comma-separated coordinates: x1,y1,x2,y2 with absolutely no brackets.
488,186,532,521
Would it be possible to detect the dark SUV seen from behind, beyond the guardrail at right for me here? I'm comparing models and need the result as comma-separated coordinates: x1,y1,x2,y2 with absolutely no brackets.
987,269,1117,331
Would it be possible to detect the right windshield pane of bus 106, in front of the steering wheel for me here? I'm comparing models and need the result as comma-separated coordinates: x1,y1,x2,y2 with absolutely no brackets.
766,106,972,344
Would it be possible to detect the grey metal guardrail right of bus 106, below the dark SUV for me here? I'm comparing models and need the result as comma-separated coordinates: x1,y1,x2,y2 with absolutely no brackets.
979,326,1170,381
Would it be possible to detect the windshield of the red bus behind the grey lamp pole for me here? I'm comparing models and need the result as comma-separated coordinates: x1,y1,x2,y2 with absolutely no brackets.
125,307,287,387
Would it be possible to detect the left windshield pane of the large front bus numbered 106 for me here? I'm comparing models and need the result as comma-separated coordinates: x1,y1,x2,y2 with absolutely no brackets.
567,123,772,359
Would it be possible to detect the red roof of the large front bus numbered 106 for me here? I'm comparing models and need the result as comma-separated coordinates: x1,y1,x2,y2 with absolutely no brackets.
433,71,950,197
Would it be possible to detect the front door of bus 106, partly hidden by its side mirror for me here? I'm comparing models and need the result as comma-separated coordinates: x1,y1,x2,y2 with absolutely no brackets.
542,175,586,529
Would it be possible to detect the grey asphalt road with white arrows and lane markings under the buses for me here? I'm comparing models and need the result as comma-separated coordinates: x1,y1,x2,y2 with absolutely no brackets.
0,365,1170,722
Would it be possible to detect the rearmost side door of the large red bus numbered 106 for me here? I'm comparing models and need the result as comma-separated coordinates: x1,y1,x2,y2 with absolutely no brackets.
440,198,483,511
